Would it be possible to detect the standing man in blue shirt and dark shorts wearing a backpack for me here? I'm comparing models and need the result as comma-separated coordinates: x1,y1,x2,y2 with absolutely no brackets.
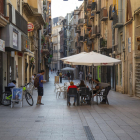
36,70,46,105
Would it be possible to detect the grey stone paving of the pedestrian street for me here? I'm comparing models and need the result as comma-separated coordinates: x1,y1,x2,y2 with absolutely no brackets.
0,74,140,140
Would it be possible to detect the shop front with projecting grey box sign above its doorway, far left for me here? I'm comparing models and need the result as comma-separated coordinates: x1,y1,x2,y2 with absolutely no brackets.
1,24,21,88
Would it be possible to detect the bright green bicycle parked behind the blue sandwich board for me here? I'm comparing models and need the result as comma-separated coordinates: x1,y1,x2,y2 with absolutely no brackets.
1,83,34,106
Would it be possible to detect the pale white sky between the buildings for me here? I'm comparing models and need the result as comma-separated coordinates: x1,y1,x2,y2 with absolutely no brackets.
51,0,84,18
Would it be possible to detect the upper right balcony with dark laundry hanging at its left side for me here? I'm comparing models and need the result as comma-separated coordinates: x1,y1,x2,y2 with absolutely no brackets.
113,12,123,28
